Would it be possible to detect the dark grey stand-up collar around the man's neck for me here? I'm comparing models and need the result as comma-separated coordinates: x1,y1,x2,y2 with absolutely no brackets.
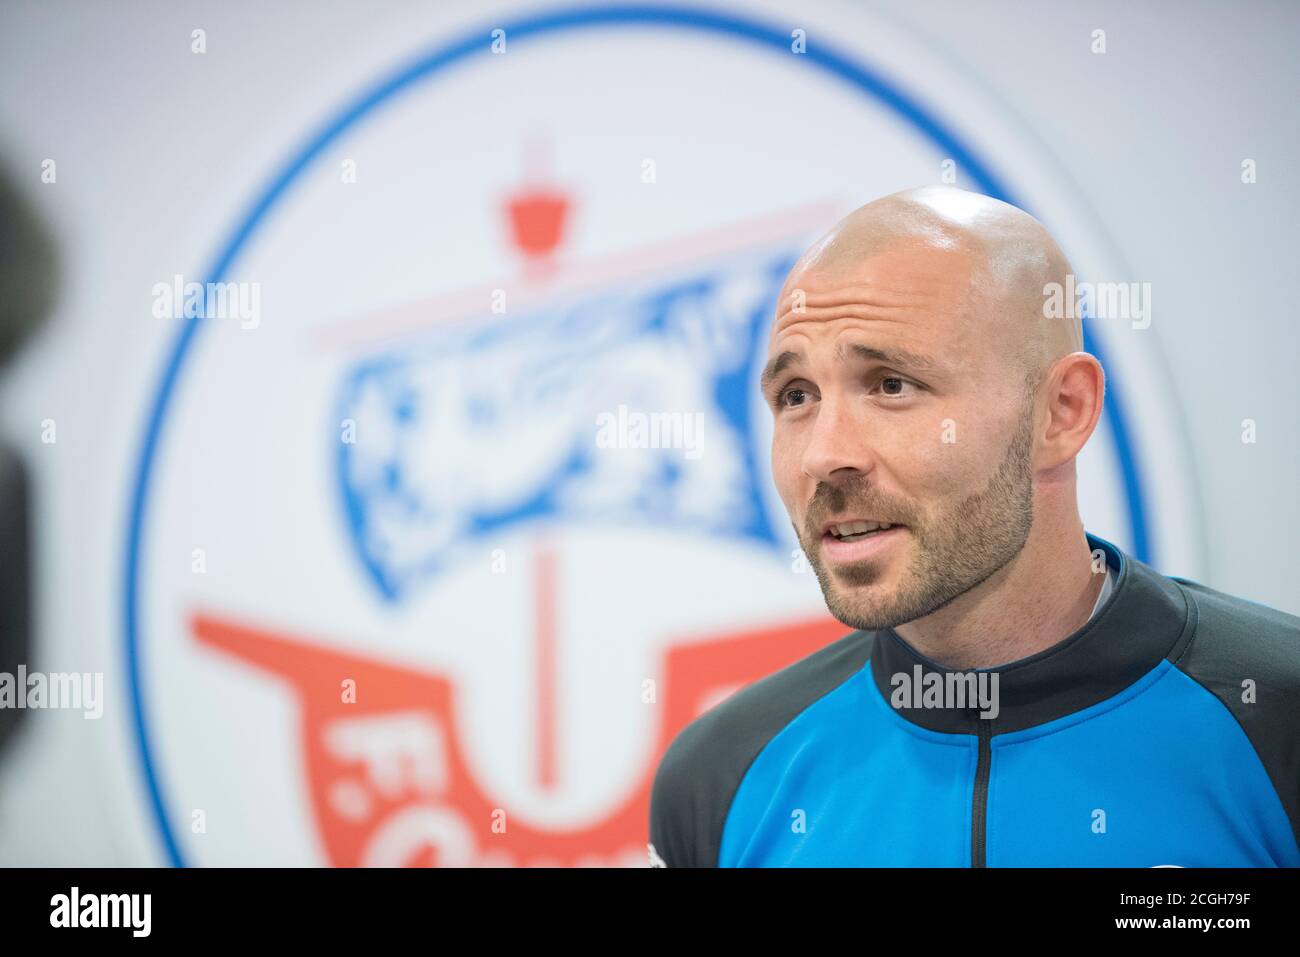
870,534,1190,735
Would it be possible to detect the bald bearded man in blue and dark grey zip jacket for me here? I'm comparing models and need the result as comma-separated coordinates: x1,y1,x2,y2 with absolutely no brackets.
650,187,1300,867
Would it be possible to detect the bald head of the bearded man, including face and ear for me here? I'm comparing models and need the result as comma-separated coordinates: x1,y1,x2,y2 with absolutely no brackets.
759,187,1105,642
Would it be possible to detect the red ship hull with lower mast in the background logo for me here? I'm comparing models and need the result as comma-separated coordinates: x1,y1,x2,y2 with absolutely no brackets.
191,551,844,867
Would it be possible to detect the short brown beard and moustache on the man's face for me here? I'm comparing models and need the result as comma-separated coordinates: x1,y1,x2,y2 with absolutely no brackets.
796,403,1034,631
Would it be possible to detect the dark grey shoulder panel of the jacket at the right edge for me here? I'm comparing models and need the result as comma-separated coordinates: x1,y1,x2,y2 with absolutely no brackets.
1170,579,1300,844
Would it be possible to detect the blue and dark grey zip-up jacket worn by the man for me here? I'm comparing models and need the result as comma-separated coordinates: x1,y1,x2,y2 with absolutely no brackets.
650,536,1300,867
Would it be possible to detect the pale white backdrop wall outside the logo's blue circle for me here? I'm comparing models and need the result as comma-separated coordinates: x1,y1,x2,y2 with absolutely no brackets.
0,0,1300,865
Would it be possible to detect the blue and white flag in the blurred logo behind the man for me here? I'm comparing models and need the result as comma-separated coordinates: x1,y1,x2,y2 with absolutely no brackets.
332,251,798,602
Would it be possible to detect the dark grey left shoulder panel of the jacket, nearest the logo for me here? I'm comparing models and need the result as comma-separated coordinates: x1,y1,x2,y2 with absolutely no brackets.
650,632,874,867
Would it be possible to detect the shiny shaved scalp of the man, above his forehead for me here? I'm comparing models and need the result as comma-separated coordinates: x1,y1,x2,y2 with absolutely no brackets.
779,186,1083,378
